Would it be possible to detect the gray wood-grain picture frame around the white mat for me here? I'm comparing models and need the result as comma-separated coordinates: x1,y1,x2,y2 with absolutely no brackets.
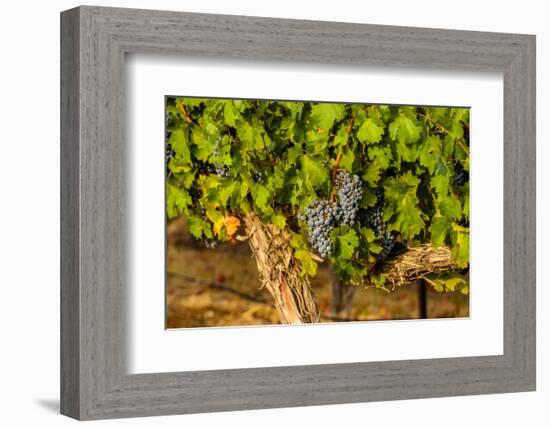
61,6,535,420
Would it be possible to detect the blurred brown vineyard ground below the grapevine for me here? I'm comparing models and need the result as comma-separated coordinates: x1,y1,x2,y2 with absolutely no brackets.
166,218,469,328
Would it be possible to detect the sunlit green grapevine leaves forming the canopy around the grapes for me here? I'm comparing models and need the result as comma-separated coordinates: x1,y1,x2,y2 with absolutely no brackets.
166,98,469,292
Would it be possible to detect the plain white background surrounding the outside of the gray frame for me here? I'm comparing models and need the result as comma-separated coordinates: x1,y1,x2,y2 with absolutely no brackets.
0,0,550,427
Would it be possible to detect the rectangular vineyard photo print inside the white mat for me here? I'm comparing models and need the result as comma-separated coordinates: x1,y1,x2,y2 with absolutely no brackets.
164,96,470,328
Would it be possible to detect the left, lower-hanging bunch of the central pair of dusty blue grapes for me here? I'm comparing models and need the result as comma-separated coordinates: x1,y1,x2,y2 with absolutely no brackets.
298,199,337,258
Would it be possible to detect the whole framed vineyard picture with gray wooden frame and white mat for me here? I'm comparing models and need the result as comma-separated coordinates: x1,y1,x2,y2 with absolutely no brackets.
61,6,536,420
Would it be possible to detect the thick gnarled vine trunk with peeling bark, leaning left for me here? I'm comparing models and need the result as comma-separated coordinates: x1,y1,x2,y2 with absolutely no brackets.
243,212,319,324
